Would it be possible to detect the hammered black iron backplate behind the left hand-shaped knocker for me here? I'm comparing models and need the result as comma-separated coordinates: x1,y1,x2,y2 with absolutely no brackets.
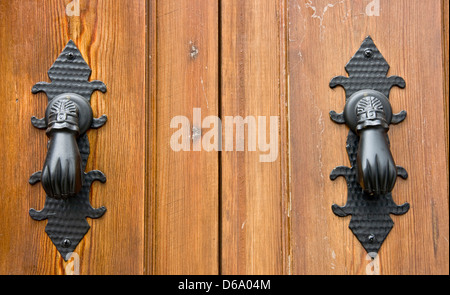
29,40,107,261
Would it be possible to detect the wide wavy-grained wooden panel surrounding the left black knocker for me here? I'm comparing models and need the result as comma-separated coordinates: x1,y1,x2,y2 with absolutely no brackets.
0,0,146,274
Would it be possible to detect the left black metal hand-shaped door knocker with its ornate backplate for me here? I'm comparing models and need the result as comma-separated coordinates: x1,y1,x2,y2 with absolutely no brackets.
29,40,107,261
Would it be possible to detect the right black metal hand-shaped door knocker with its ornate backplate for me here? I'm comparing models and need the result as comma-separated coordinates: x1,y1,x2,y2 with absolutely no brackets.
330,36,409,254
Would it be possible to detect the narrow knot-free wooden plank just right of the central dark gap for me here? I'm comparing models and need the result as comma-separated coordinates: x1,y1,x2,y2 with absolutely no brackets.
221,0,289,274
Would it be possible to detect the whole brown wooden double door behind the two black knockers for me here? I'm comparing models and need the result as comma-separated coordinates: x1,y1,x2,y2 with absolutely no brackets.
0,0,449,275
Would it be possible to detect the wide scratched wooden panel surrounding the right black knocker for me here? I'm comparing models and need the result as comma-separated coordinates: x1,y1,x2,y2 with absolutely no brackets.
288,0,449,274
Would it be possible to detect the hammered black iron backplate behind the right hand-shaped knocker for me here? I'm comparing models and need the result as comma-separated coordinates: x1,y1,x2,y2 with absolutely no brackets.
330,36,410,253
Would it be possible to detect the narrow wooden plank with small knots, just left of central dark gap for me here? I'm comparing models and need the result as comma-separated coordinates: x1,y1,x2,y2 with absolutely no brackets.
152,0,219,274
